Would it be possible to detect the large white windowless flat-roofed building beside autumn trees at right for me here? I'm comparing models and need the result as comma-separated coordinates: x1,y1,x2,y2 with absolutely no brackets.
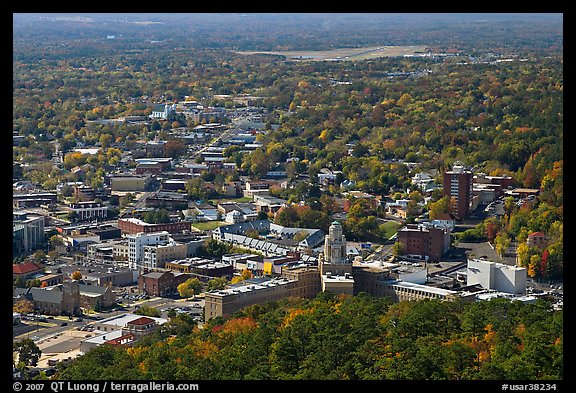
466,259,526,294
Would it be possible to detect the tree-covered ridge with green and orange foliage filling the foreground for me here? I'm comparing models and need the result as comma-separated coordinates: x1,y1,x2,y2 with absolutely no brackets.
56,292,563,380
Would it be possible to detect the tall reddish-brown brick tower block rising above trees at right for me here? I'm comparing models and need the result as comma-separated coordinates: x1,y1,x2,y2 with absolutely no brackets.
443,165,473,219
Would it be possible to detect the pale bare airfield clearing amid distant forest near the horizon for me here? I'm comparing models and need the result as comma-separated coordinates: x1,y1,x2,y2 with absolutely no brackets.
237,45,426,61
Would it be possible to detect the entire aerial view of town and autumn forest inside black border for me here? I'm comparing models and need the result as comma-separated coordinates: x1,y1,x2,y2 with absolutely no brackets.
12,13,564,382
